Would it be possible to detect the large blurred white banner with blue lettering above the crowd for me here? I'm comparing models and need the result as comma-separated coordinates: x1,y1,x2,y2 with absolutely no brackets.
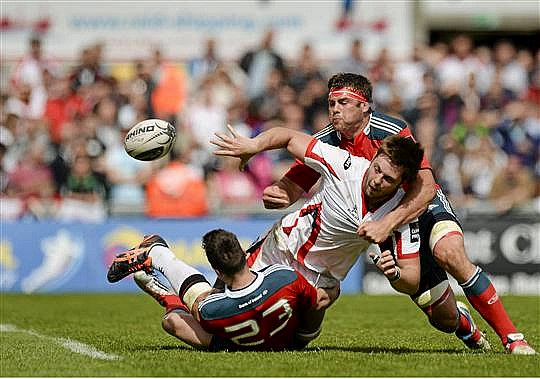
2,0,413,60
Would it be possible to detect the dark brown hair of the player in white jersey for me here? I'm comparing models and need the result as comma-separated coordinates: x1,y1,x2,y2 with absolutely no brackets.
374,135,424,182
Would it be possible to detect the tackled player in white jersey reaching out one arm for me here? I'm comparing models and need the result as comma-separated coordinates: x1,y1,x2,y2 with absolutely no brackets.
211,127,423,304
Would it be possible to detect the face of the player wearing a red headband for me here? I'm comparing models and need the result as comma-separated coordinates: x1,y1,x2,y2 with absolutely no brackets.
328,95,369,139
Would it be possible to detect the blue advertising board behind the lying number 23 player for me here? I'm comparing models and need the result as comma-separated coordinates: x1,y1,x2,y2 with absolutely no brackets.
0,218,362,293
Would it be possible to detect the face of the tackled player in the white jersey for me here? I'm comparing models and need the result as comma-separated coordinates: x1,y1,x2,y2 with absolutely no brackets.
363,154,403,200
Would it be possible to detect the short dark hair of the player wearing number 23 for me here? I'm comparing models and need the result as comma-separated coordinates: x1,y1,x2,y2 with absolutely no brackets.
202,229,246,277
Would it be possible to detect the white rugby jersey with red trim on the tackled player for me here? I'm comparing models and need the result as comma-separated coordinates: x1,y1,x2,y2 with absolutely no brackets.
274,139,420,280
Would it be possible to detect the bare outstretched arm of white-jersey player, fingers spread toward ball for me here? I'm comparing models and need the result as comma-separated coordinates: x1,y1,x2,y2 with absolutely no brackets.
210,125,313,169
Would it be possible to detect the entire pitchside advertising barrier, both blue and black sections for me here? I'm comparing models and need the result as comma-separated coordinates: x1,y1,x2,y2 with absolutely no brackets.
0,215,540,295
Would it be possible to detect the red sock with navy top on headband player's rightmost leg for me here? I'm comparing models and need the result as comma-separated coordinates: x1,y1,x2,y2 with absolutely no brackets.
461,268,517,345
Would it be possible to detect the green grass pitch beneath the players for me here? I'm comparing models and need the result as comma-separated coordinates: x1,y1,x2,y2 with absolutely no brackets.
0,294,540,377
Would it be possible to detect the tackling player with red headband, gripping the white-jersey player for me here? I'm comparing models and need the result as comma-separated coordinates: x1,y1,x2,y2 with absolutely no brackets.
263,73,535,354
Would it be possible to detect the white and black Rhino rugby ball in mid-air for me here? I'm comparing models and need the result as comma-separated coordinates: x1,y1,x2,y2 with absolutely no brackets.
124,118,176,161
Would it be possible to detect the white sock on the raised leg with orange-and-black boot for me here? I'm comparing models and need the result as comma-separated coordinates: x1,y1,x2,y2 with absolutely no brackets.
148,245,202,294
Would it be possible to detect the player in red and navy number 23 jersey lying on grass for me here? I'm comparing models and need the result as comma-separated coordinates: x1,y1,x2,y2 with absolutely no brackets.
107,229,322,351
